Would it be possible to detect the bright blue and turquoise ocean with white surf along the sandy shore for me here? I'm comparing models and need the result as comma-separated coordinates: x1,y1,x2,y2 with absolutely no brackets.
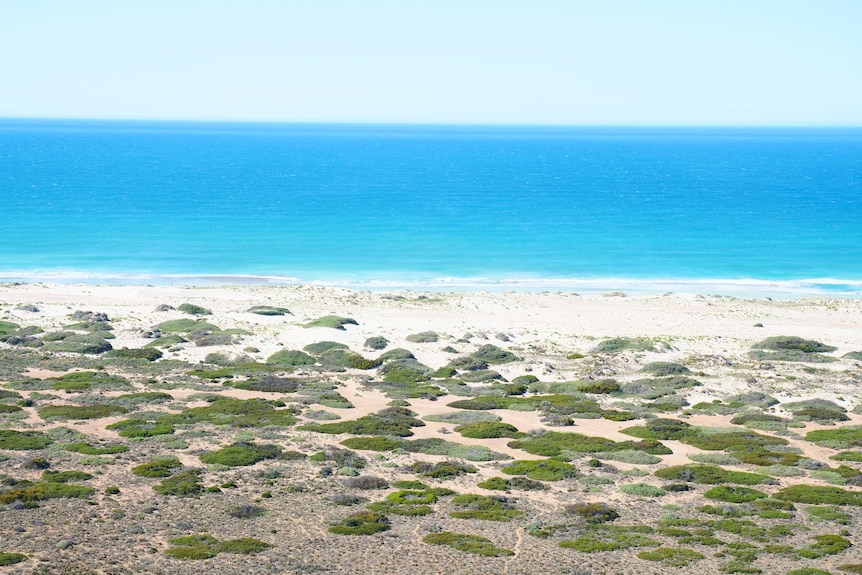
0,120,862,291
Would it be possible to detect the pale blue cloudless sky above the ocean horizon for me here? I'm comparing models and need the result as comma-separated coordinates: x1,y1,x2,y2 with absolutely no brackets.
0,0,862,126
